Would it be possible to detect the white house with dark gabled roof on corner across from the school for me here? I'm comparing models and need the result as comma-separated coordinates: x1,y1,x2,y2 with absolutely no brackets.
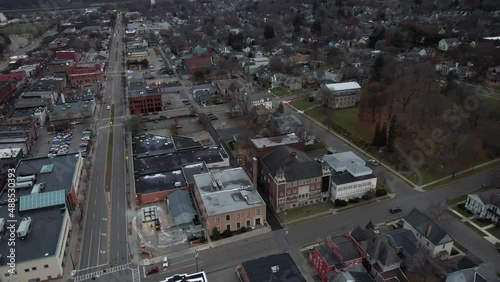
403,208,453,259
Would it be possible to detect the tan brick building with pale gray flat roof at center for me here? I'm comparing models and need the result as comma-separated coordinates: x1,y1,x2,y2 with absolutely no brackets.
194,167,266,235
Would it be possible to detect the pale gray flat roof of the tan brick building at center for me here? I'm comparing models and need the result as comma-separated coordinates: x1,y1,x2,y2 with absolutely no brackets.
194,167,265,216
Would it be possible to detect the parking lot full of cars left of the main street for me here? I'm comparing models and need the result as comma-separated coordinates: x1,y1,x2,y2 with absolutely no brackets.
31,124,91,157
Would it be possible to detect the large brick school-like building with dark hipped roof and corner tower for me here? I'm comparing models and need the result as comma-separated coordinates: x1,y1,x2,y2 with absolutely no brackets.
260,146,330,212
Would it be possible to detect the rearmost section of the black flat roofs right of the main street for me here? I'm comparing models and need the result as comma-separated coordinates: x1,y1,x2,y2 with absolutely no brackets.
132,134,175,158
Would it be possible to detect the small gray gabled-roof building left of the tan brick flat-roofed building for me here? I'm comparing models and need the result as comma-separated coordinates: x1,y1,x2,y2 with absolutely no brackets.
167,190,196,227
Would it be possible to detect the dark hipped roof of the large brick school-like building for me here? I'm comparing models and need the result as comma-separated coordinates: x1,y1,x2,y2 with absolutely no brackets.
261,146,323,181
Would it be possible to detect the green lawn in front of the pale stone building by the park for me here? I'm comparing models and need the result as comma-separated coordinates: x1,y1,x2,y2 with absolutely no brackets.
306,107,374,143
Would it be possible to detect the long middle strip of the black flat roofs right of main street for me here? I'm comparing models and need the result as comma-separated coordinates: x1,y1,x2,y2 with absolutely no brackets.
134,148,224,177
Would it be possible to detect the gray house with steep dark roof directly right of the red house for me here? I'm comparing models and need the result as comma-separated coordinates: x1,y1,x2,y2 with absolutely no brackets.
351,226,408,282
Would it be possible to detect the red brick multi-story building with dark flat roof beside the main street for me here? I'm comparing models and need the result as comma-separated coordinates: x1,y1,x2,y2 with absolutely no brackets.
127,87,163,115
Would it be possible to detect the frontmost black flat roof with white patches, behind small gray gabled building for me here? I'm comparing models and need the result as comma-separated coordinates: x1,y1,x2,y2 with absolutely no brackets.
135,170,187,194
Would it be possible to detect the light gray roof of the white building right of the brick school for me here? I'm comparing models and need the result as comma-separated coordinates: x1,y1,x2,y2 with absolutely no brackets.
323,151,373,177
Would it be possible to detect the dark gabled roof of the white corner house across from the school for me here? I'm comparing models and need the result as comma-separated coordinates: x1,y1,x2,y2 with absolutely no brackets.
404,208,453,246
